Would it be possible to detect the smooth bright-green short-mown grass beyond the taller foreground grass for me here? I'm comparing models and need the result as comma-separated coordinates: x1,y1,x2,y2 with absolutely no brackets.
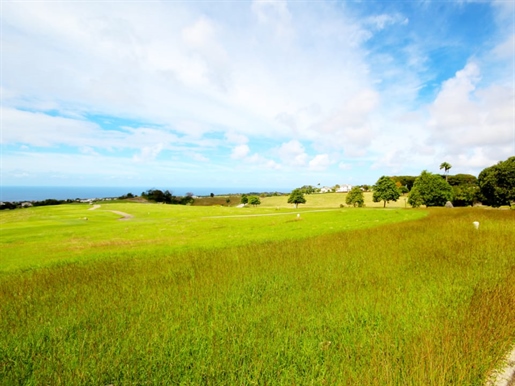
0,203,426,274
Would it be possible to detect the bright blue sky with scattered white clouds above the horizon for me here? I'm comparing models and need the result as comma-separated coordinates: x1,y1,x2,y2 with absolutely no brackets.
0,0,515,190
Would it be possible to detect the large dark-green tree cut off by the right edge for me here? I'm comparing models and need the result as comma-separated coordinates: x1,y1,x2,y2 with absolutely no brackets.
478,157,515,207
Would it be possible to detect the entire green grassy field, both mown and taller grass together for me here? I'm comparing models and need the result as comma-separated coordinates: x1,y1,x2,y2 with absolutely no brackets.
0,202,515,385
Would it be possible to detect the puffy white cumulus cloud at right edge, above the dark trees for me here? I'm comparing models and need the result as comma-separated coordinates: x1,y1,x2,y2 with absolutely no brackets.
428,62,515,159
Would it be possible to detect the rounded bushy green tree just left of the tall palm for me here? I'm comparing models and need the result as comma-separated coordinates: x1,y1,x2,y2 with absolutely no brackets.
408,170,452,206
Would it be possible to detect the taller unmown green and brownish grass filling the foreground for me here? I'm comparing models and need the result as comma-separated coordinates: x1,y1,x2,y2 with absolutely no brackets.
0,209,515,385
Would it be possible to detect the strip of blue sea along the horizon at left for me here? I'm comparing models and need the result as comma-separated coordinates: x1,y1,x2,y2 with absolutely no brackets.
0,186,291,202
